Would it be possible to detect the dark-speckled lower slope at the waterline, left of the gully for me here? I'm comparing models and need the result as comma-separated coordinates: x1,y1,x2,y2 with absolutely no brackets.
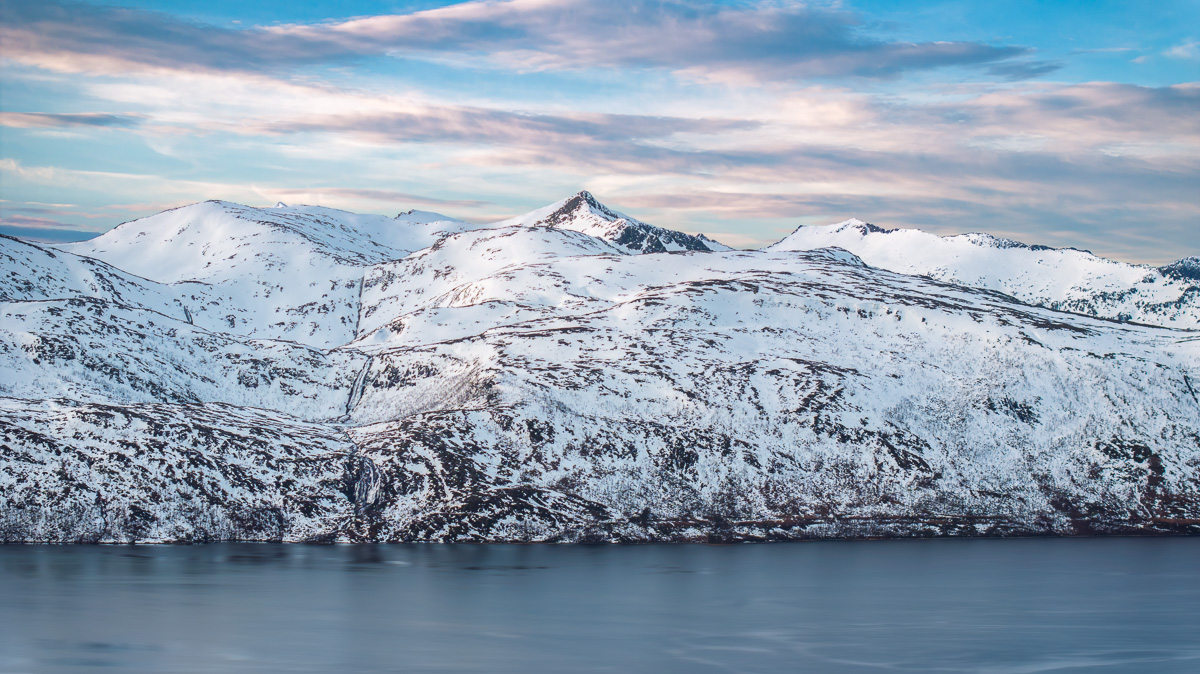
0,398,354,543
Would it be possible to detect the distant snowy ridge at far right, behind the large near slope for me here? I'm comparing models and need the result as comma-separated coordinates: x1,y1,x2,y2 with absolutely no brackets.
768,219,1200,329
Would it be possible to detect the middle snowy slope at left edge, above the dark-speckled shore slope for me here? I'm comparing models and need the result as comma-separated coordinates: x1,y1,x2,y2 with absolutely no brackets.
0,297,364,420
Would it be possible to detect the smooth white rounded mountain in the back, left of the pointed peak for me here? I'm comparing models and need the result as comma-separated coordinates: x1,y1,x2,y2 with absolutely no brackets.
59,201,473,348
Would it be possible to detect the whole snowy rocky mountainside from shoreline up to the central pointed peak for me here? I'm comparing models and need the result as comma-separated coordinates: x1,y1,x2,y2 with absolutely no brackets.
0,193,1200,542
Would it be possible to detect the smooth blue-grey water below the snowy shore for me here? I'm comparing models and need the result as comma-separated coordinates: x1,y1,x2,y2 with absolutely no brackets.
0,538,1200,674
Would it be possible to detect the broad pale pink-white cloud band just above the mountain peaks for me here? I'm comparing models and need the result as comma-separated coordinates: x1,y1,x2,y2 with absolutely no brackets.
9,78,1200,233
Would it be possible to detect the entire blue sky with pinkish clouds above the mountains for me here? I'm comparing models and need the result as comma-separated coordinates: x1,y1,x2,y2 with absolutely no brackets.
0,0,1200,264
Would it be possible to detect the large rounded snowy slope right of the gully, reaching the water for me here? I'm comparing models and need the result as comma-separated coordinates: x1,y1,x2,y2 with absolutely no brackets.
340,243,1200,540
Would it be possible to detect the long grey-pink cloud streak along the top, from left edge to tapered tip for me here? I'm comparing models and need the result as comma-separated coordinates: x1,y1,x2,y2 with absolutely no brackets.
0,0,1030,79
